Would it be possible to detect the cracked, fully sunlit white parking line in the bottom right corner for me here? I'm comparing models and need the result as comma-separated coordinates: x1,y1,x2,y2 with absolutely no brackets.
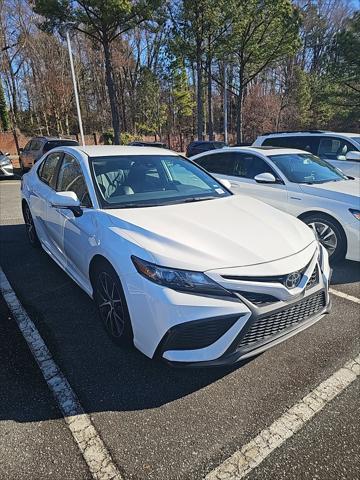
205,354,360,480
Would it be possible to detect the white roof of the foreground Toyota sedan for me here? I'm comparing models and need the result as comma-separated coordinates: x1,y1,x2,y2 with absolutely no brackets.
63,145,178,157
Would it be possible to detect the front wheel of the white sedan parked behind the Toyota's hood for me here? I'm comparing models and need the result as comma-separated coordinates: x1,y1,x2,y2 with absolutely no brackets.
302,213,346,263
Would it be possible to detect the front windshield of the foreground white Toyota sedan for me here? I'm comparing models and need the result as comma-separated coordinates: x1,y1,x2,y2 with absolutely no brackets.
90,155,231,208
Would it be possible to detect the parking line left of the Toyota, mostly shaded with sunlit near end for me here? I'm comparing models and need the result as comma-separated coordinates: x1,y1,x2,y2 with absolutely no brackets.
0,267,123,480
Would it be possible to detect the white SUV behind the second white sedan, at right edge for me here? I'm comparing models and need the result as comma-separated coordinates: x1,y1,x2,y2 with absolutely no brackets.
253,130,360,177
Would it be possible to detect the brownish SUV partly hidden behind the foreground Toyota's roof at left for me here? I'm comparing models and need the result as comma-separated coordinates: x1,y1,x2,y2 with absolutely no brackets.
19,137,79,173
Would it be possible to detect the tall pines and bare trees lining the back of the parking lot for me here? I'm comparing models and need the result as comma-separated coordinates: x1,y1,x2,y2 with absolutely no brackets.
0,0,360,148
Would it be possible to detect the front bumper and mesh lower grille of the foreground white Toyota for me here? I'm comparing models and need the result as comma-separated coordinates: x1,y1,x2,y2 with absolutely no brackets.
150,244,331,367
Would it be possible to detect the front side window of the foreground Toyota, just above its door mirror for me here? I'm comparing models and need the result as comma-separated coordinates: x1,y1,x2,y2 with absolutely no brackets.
57,154,92,208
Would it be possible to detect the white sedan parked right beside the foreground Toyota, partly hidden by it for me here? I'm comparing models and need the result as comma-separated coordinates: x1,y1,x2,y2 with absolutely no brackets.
192,147,360,261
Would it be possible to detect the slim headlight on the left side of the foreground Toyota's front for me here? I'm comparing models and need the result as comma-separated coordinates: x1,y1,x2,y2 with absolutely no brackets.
131,255,233,297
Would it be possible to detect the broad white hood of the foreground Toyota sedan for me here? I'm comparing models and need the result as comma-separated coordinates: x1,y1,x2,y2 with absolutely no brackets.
107,195,315,271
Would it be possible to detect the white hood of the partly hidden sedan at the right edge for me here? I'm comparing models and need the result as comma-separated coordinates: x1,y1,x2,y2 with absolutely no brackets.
300,179,360,205
